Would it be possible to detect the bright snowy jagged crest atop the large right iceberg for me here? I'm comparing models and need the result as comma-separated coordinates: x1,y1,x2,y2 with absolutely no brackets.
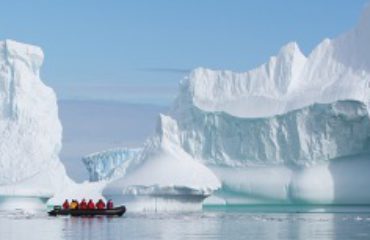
177,4,370,117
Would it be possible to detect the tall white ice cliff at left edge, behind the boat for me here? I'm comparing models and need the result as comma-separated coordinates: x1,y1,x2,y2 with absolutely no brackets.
0,40,69,202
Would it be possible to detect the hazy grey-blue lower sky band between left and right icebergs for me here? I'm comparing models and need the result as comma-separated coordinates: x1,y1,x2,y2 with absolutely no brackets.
58,100,167,182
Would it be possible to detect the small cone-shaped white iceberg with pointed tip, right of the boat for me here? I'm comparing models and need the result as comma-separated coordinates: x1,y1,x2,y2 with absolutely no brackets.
103,115,221,211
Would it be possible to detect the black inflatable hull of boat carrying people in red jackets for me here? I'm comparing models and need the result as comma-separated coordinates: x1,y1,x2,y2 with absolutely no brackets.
48,206,126,217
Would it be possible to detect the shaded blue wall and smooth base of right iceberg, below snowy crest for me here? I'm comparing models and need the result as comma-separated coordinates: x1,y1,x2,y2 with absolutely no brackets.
168,100,370,204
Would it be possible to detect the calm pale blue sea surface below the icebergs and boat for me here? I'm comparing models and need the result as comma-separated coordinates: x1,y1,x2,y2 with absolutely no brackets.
0,206,370,240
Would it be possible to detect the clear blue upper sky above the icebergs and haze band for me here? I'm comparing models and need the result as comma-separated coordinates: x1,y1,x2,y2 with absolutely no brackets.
0,0,368,106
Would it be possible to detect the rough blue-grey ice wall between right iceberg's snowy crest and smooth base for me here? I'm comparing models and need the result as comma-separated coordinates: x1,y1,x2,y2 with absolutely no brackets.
174,101,370,167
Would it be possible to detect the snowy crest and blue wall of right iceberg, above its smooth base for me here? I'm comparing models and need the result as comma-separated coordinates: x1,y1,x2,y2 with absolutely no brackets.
164,4,370,169
